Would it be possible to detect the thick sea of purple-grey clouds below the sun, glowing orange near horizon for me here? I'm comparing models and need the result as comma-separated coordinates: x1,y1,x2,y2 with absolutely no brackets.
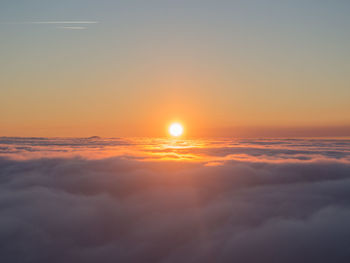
0,137,350,263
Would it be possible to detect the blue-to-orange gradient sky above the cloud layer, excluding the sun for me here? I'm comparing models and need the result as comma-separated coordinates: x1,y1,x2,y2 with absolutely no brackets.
0,0,350,136
